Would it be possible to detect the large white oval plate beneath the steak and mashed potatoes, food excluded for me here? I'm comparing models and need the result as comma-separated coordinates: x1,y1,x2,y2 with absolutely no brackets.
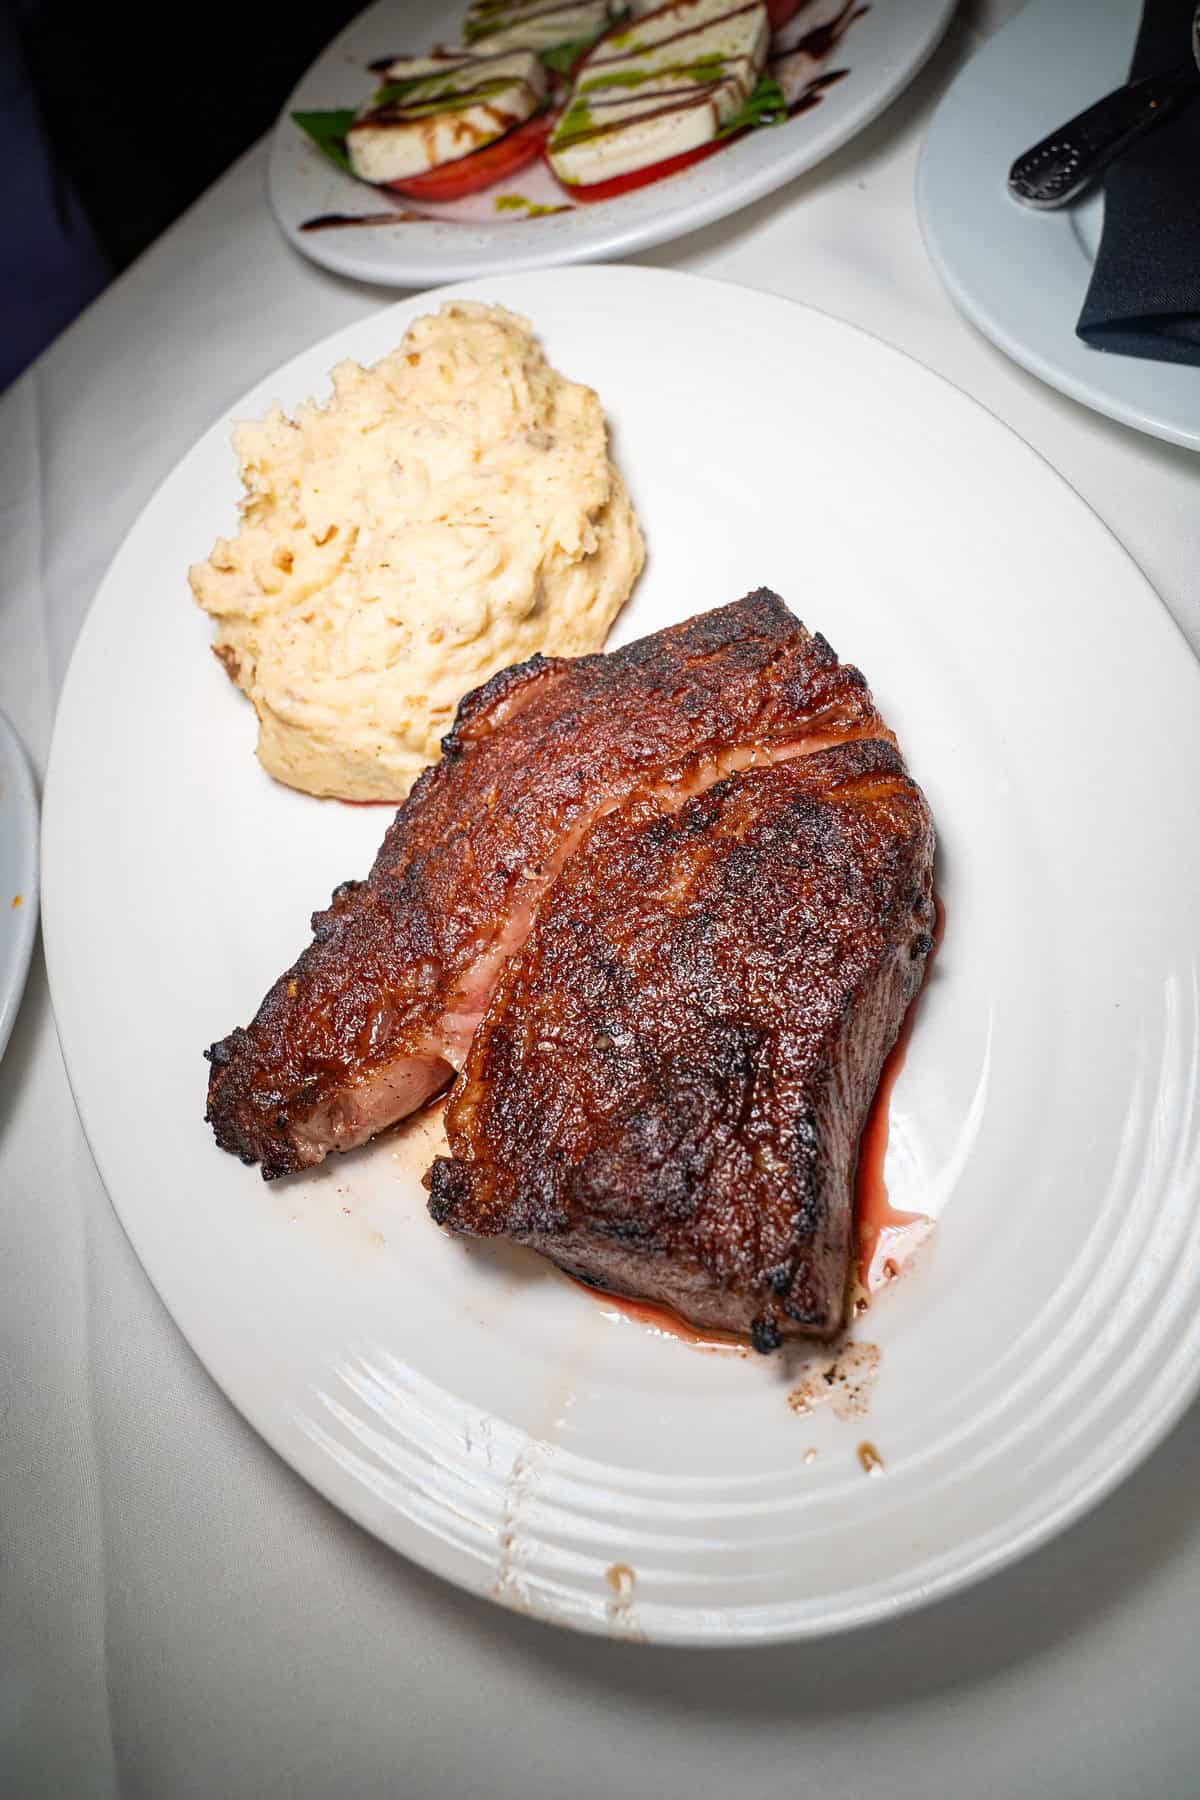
43,268,1200,1643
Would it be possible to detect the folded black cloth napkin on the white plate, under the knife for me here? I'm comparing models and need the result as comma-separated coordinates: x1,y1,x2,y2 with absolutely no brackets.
1076,0,1200,364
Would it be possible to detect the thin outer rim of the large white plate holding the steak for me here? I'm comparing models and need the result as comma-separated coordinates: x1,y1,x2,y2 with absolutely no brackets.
43,268,1200,1647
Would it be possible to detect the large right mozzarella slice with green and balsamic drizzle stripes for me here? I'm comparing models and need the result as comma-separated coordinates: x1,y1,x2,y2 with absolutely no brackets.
547,0,770,185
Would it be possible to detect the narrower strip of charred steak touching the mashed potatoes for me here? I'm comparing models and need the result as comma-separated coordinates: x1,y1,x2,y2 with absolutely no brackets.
205,589,889,1181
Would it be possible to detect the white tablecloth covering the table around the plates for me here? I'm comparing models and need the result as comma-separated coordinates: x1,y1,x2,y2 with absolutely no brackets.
9,0,1200,1800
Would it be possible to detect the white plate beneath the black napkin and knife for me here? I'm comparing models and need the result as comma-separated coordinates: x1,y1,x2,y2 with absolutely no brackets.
918,0,1200,450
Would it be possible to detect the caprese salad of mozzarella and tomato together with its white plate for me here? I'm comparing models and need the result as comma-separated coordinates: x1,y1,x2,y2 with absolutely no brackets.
268,0,954,286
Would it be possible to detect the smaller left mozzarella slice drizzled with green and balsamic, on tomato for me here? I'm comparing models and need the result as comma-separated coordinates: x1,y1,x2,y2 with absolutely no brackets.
345,50,547,184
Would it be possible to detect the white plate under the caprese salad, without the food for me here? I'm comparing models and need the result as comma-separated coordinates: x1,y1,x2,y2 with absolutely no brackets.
268,0,954,288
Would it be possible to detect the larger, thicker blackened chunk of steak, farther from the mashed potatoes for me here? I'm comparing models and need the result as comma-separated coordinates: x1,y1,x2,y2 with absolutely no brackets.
430,742,934,1350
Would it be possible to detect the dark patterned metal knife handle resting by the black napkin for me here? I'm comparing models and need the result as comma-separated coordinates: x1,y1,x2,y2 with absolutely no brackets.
1007,67,1200,209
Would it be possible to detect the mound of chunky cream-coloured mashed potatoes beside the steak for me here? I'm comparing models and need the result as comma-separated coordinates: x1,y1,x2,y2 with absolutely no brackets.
191,302,644,801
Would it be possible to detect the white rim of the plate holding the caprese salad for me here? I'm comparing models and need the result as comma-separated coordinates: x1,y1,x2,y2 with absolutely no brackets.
266,0,955,288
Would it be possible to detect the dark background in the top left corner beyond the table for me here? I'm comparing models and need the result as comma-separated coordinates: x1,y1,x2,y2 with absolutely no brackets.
0,0,362,389
